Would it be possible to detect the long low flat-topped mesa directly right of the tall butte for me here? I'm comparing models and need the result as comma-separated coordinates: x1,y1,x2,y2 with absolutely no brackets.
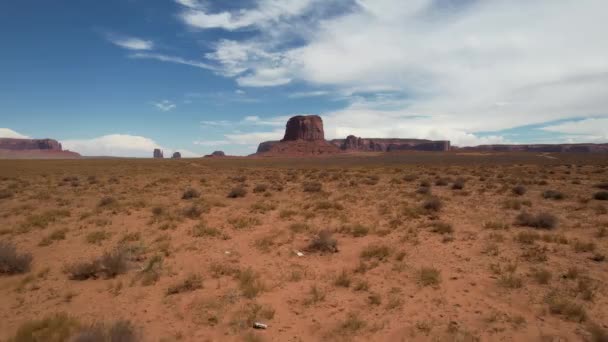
330,135,450,152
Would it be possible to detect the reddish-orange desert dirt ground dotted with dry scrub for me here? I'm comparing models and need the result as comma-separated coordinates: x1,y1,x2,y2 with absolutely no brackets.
0,153,608,341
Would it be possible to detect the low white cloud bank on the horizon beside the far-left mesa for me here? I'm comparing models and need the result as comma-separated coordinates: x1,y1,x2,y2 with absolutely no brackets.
61,134,198,158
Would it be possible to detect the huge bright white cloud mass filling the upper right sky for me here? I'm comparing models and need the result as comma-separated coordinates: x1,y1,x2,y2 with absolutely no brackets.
182,0,608,136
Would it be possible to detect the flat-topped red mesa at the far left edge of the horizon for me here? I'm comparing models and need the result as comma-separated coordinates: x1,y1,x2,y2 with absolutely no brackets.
0,138,80,159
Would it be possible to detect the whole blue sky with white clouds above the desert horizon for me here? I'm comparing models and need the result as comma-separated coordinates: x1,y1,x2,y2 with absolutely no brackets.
0,0,608,156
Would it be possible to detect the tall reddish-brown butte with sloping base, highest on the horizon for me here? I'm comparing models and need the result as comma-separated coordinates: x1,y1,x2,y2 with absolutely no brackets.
256,115,341,156
